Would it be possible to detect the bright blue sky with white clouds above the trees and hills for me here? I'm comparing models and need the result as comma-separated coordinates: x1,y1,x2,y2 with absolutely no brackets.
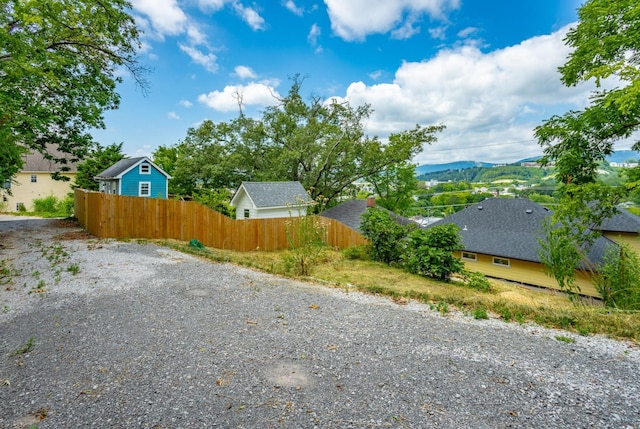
92,0,616,165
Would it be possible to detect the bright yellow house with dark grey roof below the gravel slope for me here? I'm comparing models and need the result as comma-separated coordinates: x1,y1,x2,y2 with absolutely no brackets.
429,198,616,297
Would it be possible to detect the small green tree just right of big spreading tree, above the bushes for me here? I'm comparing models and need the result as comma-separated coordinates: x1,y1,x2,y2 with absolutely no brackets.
367,162,418,215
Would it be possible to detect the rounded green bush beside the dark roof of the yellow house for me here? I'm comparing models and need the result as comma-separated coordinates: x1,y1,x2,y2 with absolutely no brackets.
403,224,464,281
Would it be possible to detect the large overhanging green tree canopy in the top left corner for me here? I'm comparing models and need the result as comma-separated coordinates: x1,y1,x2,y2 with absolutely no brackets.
0,0,143,181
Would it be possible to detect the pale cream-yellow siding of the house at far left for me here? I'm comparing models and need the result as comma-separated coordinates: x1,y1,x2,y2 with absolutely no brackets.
1,171,76,212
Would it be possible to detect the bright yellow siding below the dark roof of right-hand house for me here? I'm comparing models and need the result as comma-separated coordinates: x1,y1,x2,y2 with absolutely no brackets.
456,252,600,297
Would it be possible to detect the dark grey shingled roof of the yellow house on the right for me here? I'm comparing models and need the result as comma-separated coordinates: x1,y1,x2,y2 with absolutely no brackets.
427,198,613,263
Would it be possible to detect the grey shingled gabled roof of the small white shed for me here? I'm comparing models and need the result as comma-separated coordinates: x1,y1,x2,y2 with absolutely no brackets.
231,182,313,208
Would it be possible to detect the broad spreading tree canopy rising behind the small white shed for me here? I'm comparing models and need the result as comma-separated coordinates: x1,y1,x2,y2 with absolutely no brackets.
168,78,444,209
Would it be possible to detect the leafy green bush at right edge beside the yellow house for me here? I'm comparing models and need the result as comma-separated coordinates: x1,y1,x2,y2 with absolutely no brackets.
595,243,640,310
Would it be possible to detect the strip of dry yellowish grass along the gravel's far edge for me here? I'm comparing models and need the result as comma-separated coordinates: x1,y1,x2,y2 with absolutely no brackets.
161,241,640,342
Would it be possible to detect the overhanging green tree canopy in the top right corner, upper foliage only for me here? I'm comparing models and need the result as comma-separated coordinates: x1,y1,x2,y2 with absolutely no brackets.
536,0,640,184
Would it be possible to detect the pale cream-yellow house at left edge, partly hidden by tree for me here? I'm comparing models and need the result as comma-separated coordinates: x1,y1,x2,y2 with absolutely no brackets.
0,151,77,212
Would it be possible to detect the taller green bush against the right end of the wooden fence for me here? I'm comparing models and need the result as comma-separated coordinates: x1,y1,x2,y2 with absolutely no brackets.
360,208,409,264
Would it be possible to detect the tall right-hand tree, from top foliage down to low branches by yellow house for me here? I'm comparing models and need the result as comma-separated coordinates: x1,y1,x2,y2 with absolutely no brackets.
535,0,640,293
